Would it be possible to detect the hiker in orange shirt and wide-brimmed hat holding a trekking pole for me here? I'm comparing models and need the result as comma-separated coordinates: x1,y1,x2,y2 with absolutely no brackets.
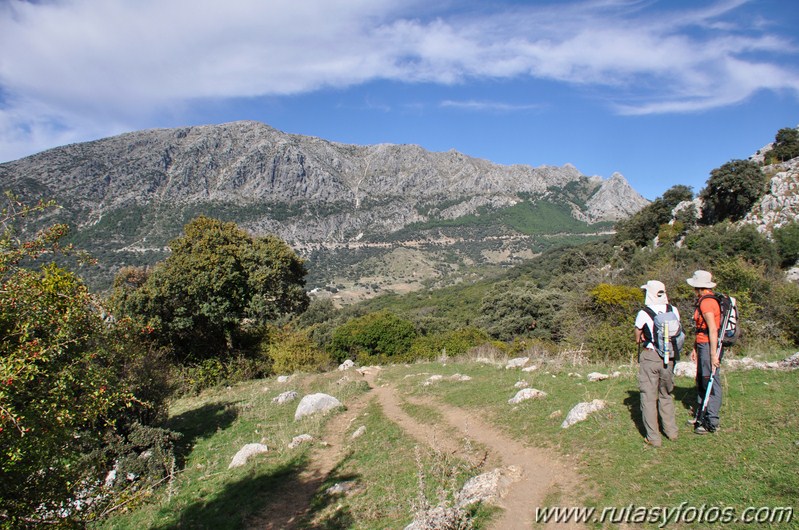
686,270,721,434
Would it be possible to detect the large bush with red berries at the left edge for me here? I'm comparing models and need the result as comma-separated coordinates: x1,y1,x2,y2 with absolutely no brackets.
0,199,176,527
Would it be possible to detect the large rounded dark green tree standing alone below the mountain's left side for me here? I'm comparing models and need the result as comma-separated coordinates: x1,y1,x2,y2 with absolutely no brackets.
113,216,308,361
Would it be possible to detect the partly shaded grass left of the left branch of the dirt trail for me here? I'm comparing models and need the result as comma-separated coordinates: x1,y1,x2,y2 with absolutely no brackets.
97,374,376,529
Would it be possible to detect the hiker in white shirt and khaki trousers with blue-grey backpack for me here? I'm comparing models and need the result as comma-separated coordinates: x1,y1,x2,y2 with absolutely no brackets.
635,280,681,447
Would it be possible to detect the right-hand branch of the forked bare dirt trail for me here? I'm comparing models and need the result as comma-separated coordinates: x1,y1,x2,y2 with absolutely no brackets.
365,371,584,530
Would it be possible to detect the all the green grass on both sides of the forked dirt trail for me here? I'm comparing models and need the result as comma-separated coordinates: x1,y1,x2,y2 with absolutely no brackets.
97,355,799,529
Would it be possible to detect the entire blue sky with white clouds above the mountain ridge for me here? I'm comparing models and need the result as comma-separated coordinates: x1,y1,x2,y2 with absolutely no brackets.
0,0,799,199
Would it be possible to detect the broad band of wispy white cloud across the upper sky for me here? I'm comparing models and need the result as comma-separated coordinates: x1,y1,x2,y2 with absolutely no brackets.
0,0,799,160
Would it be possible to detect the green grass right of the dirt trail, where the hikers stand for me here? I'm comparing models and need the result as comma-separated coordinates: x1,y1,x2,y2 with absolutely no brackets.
378,352,799,528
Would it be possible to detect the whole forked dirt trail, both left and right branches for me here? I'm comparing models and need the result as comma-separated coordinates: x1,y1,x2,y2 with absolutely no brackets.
247,369,583,530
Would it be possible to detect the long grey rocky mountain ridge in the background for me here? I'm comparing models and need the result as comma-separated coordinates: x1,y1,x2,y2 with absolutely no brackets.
0,121,648,292
